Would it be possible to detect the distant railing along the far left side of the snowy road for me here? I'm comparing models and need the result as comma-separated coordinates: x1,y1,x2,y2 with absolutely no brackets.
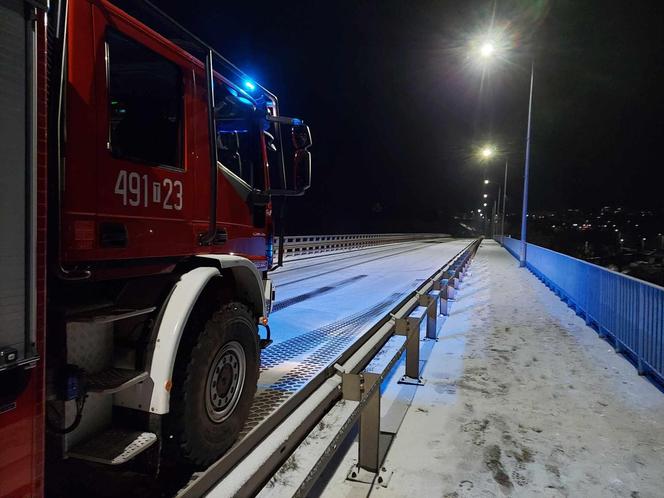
274,233,450,258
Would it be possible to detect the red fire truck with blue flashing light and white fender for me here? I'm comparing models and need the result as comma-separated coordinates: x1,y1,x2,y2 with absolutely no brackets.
0,0,311,496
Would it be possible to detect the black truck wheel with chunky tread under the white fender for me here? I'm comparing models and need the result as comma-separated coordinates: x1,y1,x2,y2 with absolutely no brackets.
164,302,260,467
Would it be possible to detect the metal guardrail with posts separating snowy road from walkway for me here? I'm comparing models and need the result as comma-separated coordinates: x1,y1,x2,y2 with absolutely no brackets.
177,239,480,498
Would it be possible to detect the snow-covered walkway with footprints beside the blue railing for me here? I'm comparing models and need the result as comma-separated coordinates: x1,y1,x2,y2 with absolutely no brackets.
318,241,664,498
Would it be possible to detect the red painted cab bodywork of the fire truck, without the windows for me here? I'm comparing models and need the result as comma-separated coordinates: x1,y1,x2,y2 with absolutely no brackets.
61,0,271,277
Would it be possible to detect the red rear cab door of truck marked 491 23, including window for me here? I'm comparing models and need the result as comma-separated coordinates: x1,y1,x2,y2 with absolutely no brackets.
88,7,196,259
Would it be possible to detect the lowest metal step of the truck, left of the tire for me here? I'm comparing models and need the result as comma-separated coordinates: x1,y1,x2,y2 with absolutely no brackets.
67,428,157,465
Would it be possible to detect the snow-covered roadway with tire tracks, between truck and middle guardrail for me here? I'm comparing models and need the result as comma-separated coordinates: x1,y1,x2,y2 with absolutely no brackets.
244,239,470,433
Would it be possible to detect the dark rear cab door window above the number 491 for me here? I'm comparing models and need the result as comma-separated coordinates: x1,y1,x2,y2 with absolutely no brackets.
106,30,182,168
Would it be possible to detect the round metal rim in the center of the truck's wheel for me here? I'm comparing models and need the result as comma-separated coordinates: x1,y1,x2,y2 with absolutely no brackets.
205,341,247,424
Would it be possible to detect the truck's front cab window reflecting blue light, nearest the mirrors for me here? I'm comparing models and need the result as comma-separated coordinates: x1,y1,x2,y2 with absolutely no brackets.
214,81,265,189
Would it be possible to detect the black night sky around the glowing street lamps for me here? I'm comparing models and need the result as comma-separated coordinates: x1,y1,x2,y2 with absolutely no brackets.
158,0,664,233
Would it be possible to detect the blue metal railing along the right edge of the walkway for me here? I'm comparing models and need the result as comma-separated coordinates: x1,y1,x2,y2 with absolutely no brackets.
498,237,664,384
